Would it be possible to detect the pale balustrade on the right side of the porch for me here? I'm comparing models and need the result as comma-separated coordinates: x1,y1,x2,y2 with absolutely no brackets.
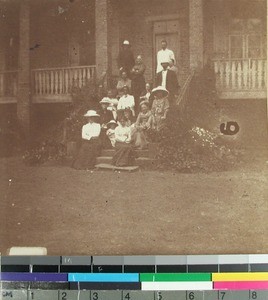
214,59,267,91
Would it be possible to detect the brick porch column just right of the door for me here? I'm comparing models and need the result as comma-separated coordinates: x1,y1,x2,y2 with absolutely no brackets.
189,0,204,70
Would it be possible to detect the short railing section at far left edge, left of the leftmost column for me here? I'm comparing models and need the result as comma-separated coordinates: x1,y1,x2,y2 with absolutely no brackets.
0,71,18,98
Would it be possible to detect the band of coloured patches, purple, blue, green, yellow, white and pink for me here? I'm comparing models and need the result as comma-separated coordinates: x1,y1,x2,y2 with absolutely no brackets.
0,272,268,291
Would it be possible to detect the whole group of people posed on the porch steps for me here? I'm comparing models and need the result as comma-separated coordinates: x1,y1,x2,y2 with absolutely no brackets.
73,41,179,169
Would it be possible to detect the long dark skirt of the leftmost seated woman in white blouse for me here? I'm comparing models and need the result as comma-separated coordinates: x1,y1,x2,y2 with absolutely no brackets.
72,139,101,170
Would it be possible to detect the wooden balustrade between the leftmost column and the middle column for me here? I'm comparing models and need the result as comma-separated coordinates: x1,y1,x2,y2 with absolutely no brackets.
32,66,96,96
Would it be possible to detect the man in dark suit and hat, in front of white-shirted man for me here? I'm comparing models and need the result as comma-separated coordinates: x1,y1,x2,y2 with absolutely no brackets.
156,62,179,105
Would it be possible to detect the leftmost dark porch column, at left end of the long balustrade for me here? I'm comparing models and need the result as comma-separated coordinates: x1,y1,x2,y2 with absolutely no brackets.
17,0,31,137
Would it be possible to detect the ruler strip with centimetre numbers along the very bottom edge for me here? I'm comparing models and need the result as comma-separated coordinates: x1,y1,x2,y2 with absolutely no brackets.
0,289,268,300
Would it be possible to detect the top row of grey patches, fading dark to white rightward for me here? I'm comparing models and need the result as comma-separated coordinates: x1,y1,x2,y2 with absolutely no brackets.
1,254,268,265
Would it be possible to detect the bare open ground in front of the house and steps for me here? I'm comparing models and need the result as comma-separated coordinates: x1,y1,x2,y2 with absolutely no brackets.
0,158,268,255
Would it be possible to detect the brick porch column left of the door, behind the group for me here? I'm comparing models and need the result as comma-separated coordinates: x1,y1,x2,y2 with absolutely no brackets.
95,0,112,85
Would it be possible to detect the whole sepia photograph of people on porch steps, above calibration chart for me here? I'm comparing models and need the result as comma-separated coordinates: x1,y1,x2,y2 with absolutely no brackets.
0,0,268,255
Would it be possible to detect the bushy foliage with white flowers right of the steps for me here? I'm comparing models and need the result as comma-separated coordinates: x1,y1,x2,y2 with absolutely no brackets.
157,69,243,172
